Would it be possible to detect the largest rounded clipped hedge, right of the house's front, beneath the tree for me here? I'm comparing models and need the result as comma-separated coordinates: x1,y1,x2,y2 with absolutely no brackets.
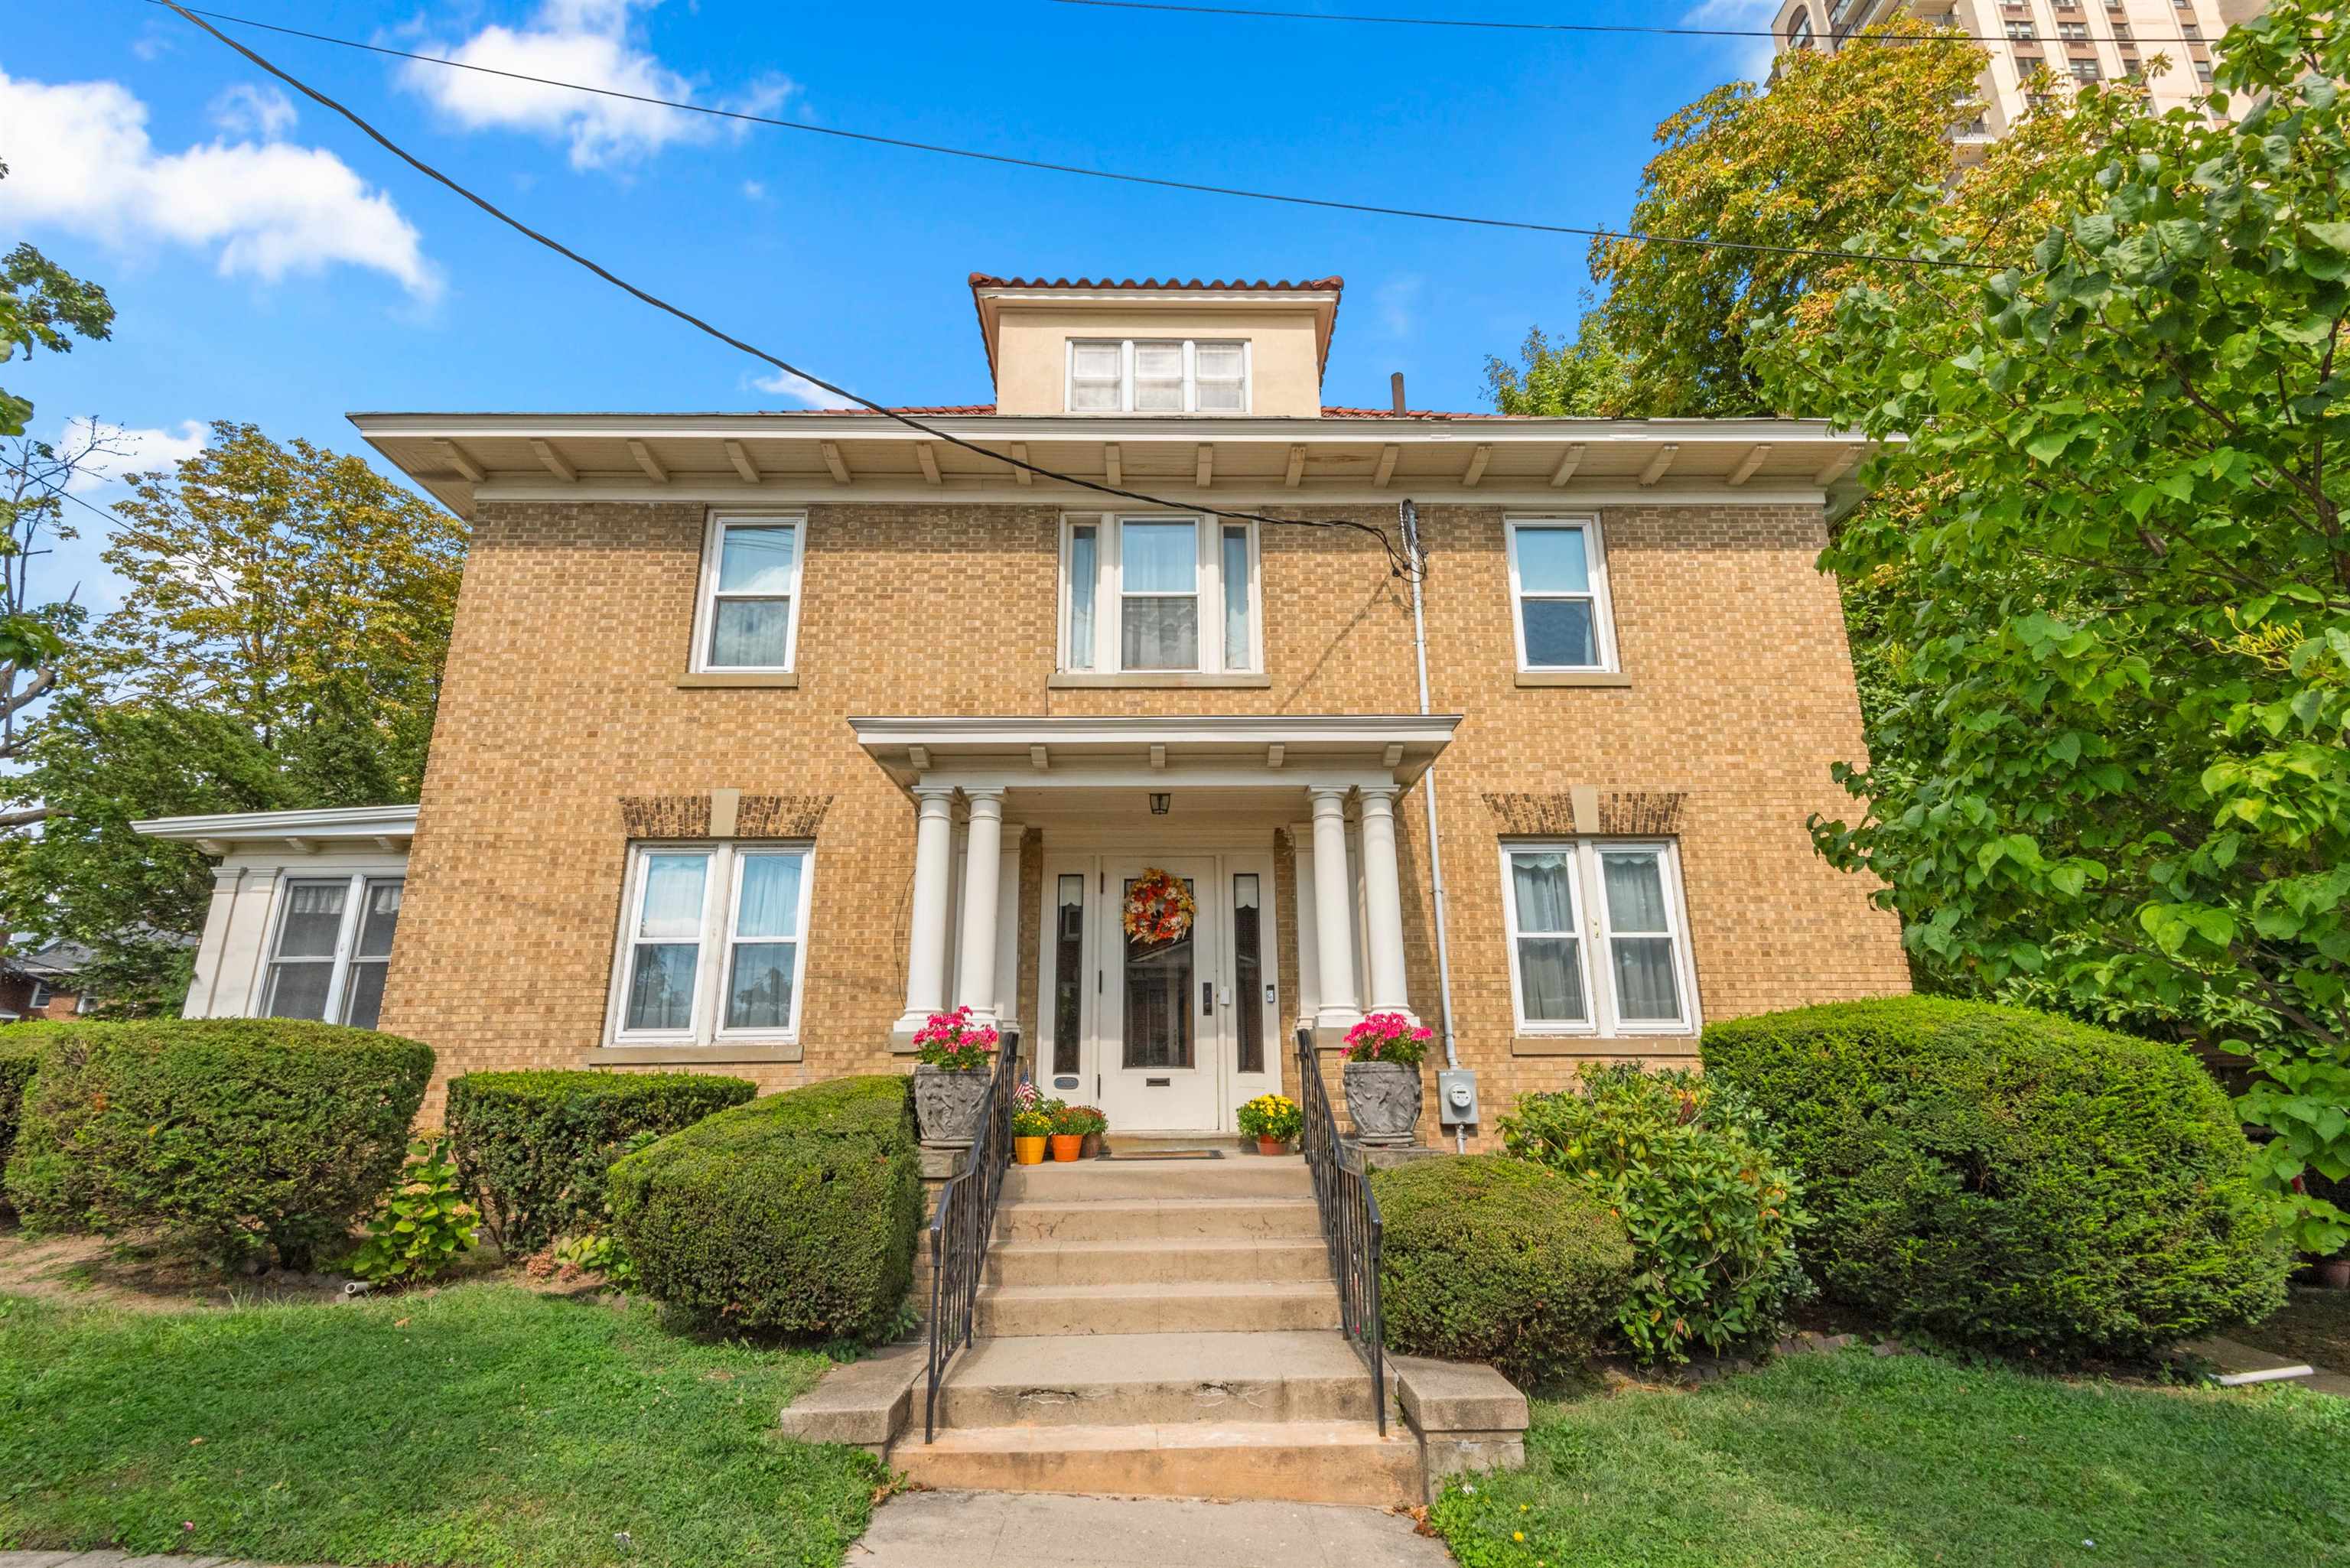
1704,997,2289,1356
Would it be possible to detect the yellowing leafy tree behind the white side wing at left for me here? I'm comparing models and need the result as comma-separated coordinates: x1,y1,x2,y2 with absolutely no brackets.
0,421,465,1011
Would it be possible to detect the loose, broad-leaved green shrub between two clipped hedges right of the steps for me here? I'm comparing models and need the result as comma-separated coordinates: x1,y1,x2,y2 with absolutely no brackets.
1502,1062,1812,1361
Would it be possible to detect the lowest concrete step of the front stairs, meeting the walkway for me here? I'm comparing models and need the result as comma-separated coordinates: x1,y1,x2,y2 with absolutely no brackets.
890,1420,1424,1505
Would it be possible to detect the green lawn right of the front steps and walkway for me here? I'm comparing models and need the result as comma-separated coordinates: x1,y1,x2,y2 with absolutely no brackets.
1434,1352,2350,1568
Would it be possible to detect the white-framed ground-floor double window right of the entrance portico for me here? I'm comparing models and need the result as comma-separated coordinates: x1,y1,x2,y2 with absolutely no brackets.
1502,839,1697,1034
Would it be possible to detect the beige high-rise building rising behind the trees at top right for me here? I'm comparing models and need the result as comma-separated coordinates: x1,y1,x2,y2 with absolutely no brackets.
1776,0,2267,162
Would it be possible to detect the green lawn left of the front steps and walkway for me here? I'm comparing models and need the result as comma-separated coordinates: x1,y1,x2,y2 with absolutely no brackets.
0,1283,884,1568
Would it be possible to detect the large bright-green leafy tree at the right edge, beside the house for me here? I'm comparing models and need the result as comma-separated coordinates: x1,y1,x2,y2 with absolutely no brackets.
1756,0,2350,1251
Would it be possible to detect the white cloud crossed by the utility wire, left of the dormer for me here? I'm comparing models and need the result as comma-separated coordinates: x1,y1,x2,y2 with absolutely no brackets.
399,0,796,169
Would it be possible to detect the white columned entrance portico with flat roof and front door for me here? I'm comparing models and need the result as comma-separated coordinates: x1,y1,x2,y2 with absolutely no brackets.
851,714,1460,1130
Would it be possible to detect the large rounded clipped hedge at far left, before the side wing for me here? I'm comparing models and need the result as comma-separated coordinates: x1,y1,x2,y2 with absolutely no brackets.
7,1018,432,1270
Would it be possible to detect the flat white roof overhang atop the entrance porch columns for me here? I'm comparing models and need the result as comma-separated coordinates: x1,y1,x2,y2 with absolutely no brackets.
848,712,1462,790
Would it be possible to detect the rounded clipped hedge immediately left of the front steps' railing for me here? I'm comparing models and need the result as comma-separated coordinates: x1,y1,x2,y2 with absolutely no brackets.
609,1075,921,1342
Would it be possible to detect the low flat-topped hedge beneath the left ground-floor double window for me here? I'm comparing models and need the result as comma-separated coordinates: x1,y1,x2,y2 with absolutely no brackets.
447,1072,759,1257
